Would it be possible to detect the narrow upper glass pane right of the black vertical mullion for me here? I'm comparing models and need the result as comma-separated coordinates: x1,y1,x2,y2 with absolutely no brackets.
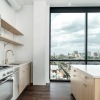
87,13,100,60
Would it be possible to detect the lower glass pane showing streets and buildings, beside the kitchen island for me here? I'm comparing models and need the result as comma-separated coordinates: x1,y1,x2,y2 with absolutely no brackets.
50,61,85,80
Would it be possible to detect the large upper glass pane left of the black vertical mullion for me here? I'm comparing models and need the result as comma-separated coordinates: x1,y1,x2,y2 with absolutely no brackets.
51,13,85,60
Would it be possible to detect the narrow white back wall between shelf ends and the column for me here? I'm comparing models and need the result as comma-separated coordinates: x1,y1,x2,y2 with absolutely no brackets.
15,5,33,82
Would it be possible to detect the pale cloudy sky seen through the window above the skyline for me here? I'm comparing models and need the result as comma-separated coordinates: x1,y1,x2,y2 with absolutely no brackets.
51,13,100,55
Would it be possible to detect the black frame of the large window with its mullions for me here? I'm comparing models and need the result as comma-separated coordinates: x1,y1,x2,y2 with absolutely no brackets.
49,6,100,81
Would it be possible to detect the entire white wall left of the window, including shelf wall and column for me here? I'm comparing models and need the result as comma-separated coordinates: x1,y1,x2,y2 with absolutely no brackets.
0,0,49,85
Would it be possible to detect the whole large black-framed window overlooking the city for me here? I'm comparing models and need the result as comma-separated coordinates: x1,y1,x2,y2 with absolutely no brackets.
50,7,100,80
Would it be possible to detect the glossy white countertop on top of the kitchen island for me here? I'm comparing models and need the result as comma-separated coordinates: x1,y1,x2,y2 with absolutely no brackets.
71,65,100,78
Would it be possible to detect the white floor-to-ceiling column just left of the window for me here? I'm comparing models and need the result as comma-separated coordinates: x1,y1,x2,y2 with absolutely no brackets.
33,0,49,85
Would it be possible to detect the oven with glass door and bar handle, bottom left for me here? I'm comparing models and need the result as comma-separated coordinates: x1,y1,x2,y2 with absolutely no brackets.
0,75,13,100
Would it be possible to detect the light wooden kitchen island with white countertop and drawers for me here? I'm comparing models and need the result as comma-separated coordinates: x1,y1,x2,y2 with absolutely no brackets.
71,65,100,100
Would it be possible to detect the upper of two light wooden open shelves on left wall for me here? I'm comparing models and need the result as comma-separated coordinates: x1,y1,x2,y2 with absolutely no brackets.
1,19,23,35
